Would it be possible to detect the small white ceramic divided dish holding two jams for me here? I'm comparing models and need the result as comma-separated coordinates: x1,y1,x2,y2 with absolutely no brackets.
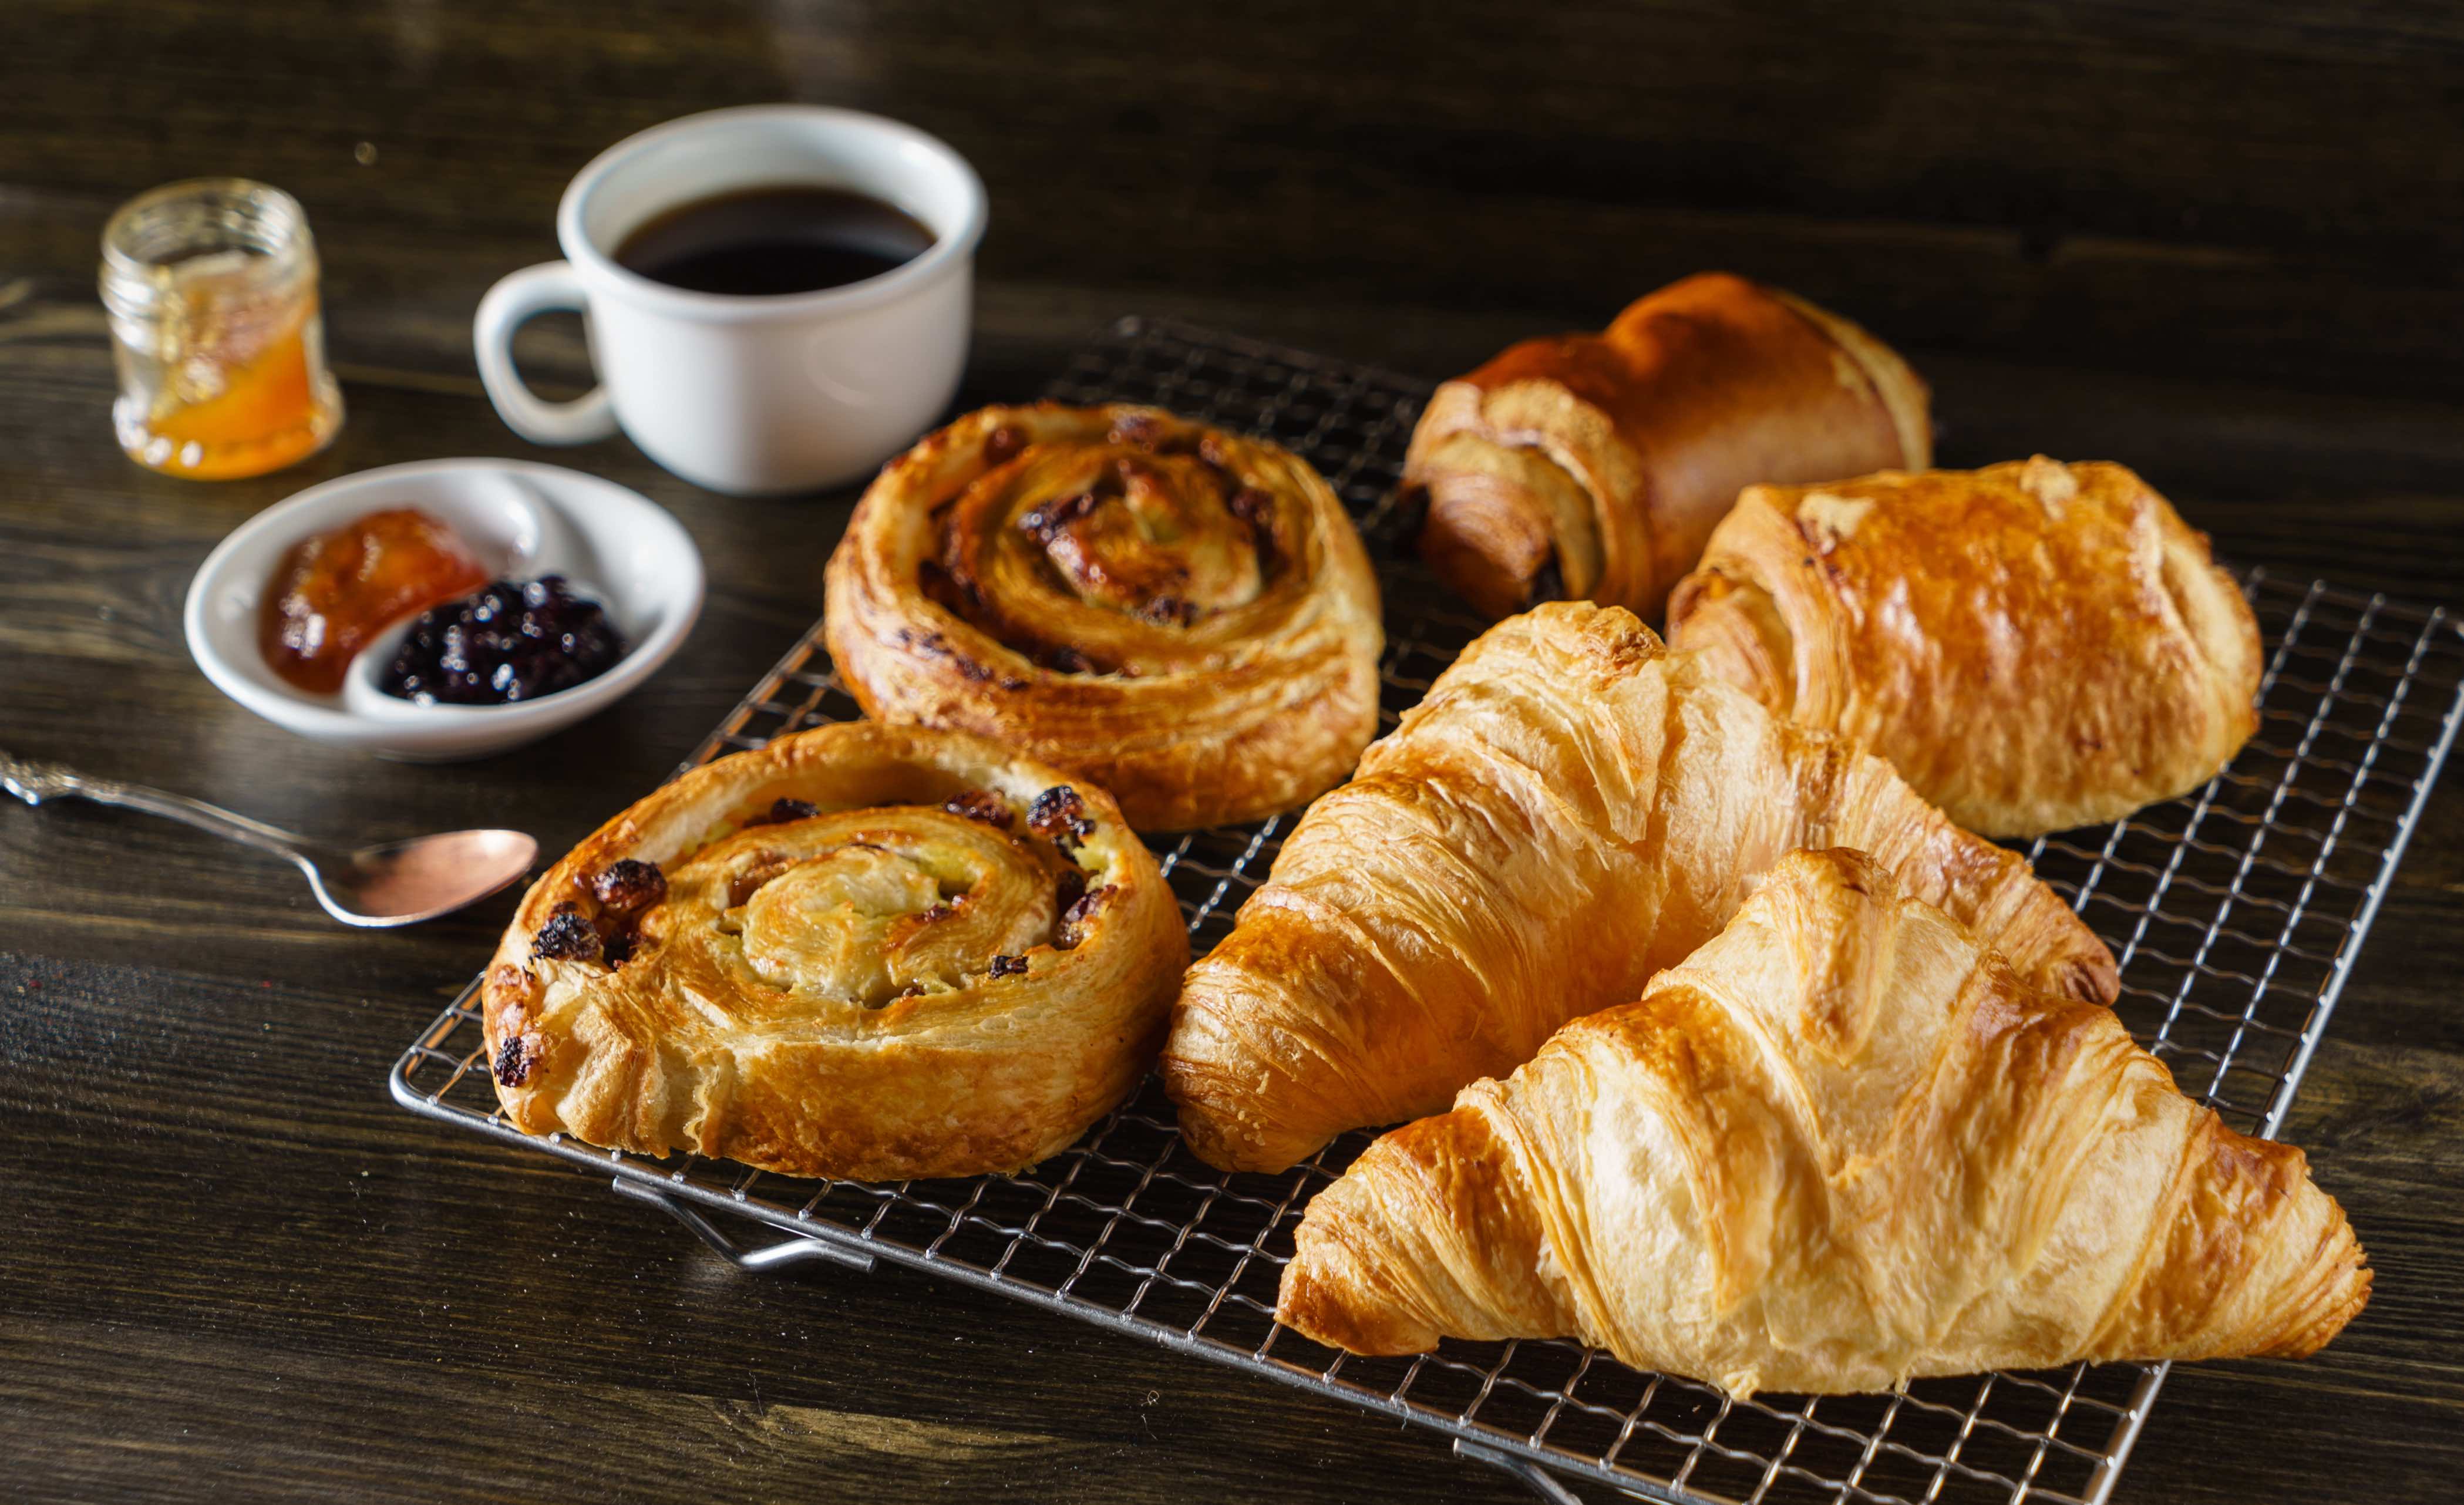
185,460,702,761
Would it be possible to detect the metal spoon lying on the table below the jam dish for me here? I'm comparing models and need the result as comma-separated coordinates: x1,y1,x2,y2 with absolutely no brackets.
0,751,540,928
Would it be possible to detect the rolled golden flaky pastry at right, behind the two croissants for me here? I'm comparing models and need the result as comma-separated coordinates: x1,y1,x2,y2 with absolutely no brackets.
1668,456,2262,835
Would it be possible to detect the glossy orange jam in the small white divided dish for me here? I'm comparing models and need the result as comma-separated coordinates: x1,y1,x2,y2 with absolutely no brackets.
259,507,490,695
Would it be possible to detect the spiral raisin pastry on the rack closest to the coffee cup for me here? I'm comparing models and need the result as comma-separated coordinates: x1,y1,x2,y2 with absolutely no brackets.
828,404,1382,830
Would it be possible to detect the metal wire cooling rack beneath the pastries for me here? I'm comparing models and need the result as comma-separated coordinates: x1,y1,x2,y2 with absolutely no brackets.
392,320,2464,1505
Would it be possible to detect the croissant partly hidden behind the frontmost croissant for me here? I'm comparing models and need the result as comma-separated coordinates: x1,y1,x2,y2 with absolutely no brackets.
1163,604,2116,1170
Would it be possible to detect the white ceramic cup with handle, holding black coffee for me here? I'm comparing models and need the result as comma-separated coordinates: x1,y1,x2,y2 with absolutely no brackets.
470,103,985,495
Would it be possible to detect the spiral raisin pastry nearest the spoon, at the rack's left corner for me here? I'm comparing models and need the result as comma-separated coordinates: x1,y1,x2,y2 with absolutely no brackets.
483,722,1190,1180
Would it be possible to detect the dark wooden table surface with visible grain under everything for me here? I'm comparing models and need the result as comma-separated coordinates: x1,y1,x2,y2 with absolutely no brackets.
0,0,2464,1500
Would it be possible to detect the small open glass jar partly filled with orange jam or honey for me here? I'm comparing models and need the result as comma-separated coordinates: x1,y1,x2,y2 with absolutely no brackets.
101,177,342,480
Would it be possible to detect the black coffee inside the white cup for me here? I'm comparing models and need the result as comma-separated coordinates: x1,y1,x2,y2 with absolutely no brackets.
616,185,934,298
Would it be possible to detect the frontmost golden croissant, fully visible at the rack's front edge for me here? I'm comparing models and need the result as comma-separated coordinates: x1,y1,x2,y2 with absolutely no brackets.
1279,850,2371,1394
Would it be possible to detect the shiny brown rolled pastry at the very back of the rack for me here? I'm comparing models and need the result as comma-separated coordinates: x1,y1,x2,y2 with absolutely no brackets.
1402,271,1932,616
